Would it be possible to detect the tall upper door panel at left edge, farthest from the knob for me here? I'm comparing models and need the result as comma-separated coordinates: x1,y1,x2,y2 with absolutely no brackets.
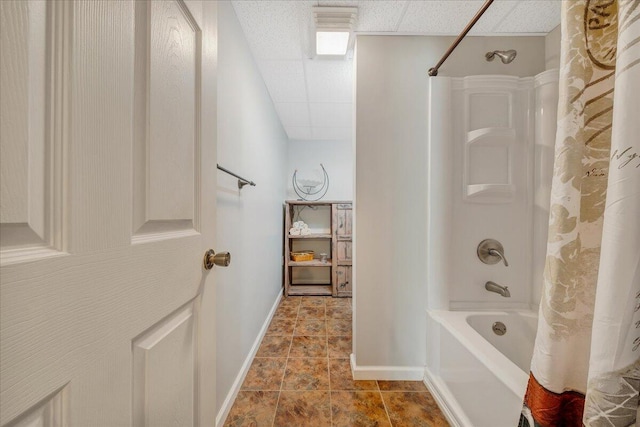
0,1,59,262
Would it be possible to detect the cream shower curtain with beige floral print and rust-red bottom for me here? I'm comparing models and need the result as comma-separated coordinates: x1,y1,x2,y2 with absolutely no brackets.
521,0,640,427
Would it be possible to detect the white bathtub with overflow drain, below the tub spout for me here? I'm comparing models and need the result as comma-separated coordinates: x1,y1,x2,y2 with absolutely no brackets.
425,310,537,427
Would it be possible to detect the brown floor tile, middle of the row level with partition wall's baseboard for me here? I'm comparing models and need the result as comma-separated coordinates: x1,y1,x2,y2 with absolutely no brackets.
282,357,329,390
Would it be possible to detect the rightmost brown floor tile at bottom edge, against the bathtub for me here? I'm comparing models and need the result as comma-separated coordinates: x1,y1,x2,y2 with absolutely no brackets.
382,391,449,427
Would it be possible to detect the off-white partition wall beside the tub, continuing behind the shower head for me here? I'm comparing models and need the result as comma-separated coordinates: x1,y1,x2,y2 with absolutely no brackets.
354,36,545,369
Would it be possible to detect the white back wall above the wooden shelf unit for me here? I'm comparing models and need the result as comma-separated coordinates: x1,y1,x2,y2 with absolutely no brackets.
287,140,354,200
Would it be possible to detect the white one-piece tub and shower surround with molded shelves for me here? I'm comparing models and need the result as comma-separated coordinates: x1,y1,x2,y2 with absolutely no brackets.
425,70,558,426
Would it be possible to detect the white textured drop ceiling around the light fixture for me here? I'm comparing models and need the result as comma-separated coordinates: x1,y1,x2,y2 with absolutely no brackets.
232,0,560,141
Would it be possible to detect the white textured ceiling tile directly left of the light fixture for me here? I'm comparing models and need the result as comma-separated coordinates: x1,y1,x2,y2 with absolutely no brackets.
232,1,316,59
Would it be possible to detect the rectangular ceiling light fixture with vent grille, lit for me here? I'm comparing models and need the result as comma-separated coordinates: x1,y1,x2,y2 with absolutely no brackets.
313,6,358,58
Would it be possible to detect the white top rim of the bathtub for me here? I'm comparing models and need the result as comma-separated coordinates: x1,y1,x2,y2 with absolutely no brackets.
427,310,535,397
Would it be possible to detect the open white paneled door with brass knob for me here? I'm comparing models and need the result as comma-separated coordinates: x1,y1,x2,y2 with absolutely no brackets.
0,0,217,427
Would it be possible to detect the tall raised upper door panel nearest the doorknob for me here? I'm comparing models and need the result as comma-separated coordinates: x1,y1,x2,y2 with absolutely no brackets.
134,1,201,237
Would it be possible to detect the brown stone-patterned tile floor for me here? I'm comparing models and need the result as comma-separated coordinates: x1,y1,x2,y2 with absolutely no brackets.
225,297,449,427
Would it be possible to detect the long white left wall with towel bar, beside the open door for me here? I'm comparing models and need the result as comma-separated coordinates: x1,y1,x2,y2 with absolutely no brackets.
214,2,288,422
